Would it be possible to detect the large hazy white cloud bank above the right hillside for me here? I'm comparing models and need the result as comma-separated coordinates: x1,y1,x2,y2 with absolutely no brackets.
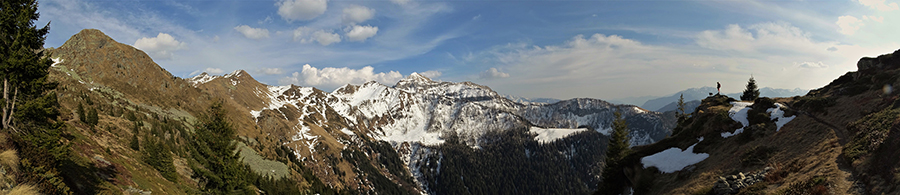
475,22,884,98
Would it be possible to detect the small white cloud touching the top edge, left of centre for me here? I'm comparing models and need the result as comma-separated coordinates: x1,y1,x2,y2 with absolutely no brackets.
275,0,328,22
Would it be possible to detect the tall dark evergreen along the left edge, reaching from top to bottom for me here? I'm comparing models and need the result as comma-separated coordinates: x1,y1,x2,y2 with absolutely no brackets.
0,0,72,194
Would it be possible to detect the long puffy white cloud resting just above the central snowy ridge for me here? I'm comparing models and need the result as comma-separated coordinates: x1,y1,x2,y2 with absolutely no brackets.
279,64,403,89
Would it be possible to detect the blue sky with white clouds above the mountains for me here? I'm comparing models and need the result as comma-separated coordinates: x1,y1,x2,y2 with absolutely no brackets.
37,0,900,99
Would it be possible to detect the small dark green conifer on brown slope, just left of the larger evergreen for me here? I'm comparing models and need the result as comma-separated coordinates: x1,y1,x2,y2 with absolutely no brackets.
143,136,178,181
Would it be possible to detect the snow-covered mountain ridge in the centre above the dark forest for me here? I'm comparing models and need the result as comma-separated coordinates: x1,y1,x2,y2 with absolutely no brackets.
202,73,674,192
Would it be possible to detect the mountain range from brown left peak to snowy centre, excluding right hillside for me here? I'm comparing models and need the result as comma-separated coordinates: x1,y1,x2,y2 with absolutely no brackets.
37,29,675,194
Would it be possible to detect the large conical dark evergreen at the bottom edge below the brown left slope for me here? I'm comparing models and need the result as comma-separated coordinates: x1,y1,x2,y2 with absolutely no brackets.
191,102,253,194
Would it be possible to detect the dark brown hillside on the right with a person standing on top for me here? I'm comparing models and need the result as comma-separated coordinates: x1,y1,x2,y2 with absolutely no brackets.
625,50,900,194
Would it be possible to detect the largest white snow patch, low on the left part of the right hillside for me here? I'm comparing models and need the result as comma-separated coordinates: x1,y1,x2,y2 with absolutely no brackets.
641,137,709,173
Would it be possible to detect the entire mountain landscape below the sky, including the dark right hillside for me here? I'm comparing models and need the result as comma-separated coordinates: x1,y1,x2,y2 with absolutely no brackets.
12,29,900,194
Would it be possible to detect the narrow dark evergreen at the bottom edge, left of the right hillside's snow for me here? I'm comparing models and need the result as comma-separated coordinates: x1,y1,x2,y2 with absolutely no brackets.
596,111,631,194
